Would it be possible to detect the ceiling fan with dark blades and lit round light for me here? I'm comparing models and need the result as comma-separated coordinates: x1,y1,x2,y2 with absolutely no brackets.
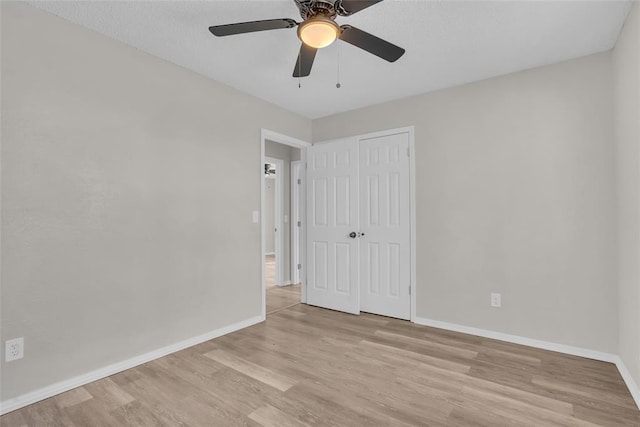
209,0,405,77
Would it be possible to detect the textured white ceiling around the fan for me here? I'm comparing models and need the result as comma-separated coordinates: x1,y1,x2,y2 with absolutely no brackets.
30,0,631,118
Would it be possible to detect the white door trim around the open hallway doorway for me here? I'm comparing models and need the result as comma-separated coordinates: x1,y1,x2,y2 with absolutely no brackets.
259,129,311,320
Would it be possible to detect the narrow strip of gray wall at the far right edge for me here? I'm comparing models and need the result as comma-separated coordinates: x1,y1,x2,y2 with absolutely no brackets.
613,4,640,385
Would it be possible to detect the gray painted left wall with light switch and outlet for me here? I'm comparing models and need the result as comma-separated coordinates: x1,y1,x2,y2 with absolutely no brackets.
1,2,311,400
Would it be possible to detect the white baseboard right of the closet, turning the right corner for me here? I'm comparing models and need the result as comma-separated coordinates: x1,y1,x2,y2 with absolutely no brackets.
414,317,640,409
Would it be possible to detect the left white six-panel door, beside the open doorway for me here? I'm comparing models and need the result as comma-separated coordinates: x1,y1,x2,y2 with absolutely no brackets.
307,139,360,314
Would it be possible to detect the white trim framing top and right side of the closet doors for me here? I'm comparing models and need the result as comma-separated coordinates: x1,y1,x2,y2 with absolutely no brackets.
302,126,417,323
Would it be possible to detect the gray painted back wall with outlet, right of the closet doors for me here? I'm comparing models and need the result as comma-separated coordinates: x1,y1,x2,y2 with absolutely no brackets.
313,53,618,353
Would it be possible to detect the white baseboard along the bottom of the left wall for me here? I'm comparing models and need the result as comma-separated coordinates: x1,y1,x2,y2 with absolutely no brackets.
0,316,264,415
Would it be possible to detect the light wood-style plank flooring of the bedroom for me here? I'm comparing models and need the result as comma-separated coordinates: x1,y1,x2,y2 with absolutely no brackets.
0,304,640,427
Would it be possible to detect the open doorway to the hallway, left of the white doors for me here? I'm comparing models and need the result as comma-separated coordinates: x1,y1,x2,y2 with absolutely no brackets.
262,131,310,316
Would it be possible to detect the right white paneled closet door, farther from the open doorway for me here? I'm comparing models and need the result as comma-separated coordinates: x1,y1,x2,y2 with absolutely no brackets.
358,133,411,320
